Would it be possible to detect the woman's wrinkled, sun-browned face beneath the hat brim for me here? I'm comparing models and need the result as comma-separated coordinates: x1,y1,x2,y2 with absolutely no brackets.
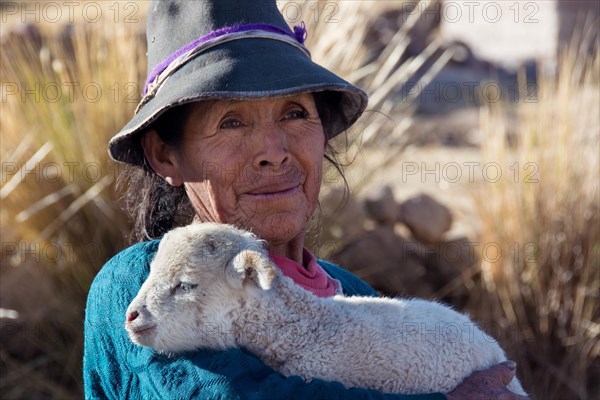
166,94,326,244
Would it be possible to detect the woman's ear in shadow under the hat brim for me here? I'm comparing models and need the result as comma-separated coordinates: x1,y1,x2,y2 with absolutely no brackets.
142,129,183,186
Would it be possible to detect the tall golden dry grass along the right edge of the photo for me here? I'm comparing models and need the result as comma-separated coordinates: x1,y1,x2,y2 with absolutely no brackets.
468,46,600,399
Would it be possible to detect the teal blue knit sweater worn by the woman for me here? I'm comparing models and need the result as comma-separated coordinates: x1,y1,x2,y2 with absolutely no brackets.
83,241,445,400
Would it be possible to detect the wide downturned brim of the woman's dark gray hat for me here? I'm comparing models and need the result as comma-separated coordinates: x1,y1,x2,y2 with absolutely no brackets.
109,39,367,164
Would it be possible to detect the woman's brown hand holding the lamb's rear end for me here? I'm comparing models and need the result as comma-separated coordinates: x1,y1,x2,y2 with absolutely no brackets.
447,361,528,400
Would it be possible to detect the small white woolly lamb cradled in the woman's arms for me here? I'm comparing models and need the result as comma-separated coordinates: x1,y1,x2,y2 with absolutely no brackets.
126,223,525,394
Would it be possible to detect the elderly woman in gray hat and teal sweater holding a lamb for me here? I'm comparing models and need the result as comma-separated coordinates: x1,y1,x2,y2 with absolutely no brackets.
84,0,519,399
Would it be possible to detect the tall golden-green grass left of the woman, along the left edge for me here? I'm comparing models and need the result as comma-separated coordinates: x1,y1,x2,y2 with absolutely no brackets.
0,18,145,398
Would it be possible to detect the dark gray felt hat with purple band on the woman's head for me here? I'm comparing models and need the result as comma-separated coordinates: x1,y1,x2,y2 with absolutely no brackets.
108,0,367,163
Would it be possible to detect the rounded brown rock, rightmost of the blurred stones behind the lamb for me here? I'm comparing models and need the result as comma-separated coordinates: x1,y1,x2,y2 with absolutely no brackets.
399,194,452,243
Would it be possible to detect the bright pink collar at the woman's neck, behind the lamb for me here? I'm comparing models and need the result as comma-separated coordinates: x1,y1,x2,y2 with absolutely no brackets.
269,249,341,297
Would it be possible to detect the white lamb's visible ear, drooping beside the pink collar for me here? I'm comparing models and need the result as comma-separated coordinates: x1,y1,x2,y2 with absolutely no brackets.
228,250,275,290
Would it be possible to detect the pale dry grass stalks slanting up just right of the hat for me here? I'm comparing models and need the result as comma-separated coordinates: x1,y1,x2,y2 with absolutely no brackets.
304,0,453,178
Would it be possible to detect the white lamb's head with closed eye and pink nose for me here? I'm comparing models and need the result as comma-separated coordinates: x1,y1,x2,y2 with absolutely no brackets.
125,223,276,353
